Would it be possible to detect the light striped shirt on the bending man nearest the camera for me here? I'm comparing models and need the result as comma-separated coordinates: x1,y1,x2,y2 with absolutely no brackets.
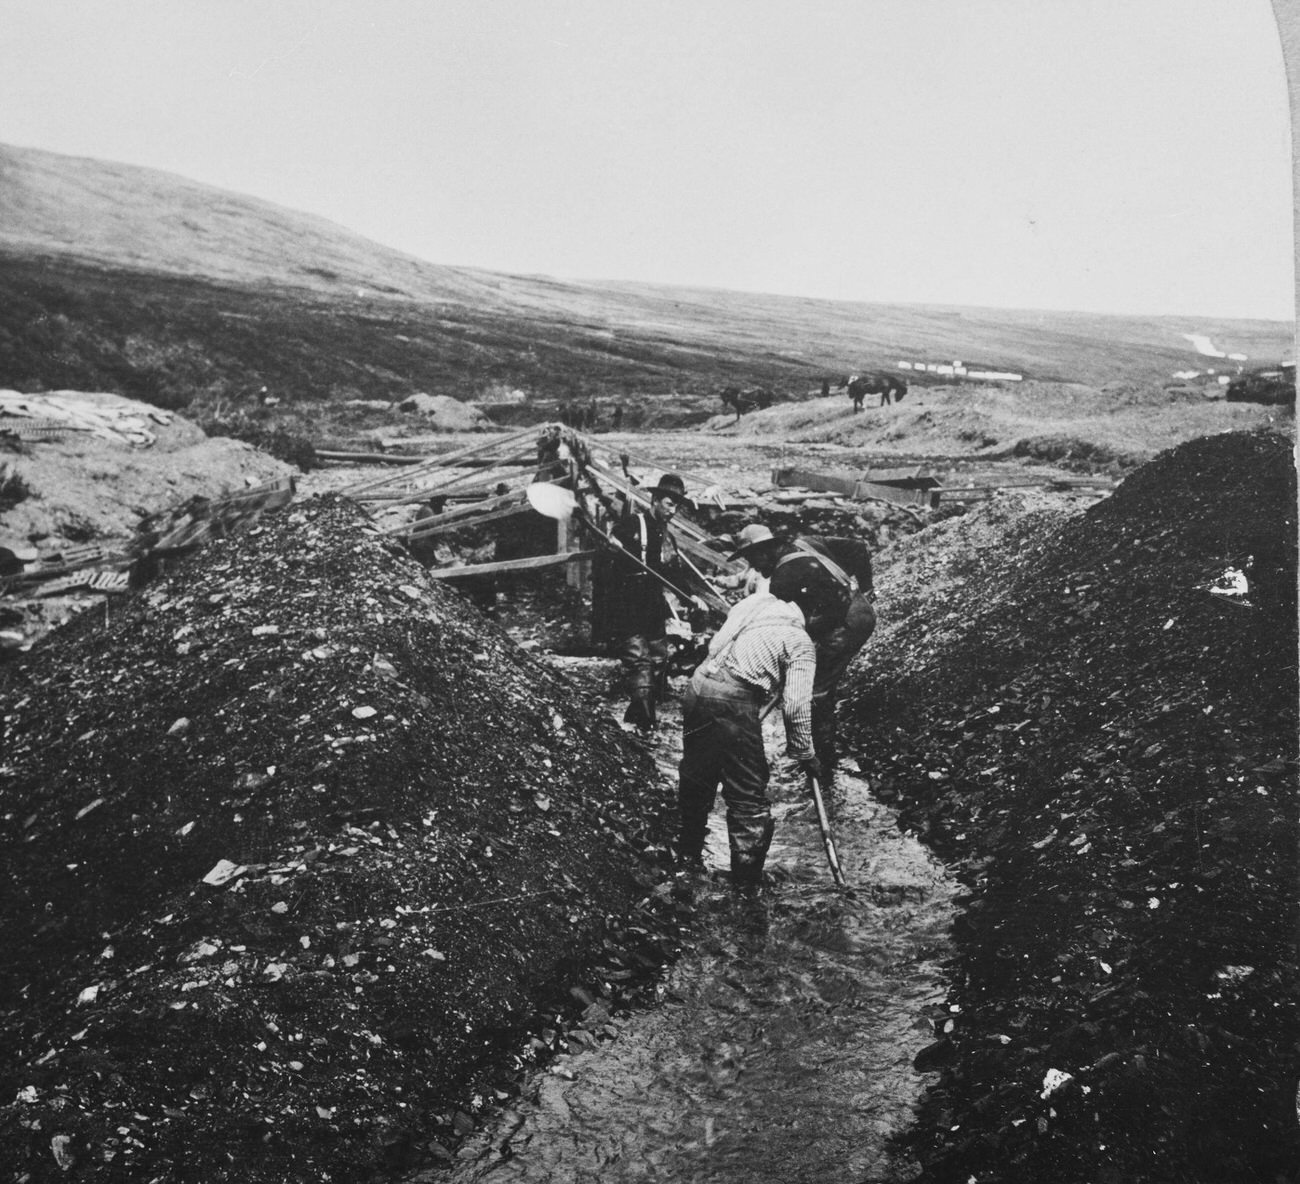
709,593,816,756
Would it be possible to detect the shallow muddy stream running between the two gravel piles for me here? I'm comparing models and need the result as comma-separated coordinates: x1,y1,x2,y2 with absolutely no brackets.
439,665,956,1184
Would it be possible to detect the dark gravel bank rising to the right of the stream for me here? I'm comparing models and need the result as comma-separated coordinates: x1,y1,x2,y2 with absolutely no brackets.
846,433,1300,1184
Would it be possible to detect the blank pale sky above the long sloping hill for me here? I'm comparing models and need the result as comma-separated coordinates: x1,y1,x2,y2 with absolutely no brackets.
0,0,1295,320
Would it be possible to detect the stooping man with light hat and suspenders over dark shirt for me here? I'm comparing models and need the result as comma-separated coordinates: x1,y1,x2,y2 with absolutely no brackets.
731,524,876,797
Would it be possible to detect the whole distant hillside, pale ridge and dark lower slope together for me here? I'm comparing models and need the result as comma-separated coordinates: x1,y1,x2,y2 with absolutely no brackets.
0,146,1292,405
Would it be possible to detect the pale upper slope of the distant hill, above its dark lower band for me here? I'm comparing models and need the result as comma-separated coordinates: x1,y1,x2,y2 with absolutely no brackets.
0,138,1292,386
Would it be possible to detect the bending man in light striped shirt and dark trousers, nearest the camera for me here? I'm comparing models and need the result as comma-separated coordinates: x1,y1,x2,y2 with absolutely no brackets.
677,591,818,886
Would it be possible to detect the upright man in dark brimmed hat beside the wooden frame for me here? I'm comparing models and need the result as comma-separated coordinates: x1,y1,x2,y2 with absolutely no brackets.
606,473,693,732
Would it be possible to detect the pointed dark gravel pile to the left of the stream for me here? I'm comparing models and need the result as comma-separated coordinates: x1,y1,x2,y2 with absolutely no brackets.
0,498,686,1181
